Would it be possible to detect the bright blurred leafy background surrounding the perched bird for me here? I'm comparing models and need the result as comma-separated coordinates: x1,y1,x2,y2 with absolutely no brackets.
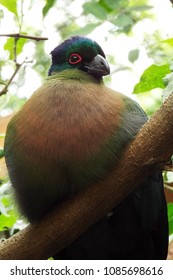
0,0,173,259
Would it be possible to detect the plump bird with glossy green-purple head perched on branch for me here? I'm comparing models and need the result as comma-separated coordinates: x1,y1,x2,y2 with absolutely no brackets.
4,36,168,260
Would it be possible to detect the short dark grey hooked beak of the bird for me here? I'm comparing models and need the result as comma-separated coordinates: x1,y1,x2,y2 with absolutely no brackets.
85,54,110,77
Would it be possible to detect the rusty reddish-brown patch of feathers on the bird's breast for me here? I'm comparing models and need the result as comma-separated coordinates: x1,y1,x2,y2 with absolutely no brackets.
16,82,123,160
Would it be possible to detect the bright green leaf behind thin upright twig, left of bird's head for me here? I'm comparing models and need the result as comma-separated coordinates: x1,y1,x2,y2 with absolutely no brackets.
4,38,27,60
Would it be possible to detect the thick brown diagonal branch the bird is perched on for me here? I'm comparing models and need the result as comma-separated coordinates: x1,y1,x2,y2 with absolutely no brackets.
0,95,173,259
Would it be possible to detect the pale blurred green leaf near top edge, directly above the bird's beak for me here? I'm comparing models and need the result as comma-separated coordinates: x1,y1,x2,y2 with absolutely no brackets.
83,2,107,20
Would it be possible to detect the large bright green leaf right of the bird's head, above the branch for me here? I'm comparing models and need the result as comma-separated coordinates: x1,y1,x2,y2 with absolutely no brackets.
133,64,171,94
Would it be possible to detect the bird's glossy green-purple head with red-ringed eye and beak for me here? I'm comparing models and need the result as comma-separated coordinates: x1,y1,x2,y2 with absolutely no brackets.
48,36,110,80
